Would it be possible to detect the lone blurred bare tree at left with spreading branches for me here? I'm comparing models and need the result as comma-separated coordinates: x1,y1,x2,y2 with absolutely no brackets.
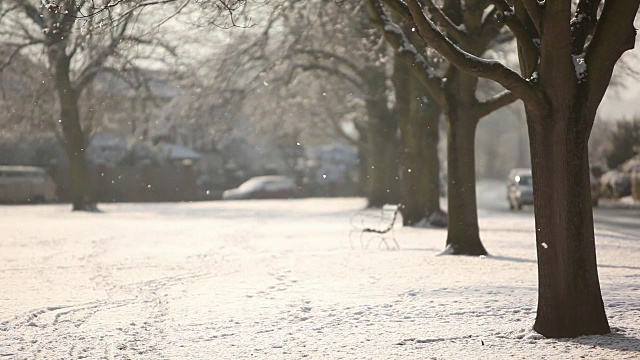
0,0,244,211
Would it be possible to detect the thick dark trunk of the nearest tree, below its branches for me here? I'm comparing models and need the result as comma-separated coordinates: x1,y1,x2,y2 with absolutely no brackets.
527,106,609,338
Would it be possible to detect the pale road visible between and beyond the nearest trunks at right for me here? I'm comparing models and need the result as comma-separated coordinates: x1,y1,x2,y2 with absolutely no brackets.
477,180,640,240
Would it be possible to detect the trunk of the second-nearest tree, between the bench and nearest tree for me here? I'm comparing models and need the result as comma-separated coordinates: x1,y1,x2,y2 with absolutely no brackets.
445,107,487,255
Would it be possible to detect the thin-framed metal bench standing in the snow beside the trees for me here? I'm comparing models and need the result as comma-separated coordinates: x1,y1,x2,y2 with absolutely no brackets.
349,204,400,249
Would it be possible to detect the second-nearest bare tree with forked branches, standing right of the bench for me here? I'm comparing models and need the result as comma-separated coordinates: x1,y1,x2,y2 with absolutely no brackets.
367,0,516,255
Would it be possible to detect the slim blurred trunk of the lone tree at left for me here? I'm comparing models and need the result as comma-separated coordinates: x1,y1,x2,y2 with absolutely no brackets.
49,47,97,211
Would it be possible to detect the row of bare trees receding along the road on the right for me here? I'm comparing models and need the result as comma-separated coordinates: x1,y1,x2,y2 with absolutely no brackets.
235,0,640,337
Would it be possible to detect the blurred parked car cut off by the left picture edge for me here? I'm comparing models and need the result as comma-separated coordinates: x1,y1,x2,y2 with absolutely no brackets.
0,166,57,203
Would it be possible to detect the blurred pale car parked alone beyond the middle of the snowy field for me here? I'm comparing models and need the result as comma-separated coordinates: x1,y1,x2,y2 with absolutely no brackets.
222,175,298,200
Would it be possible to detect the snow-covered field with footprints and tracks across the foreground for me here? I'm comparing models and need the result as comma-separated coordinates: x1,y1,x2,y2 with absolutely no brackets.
0,199,640,359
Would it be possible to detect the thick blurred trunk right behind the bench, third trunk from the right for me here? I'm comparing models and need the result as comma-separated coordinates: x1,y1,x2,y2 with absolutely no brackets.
394,60,442,225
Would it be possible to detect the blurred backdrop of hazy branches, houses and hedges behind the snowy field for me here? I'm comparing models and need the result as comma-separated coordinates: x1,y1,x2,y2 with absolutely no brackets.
0,1,640,202
